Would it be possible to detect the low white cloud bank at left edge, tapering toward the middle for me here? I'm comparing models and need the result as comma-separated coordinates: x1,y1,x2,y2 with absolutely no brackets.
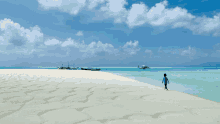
0,19,124,58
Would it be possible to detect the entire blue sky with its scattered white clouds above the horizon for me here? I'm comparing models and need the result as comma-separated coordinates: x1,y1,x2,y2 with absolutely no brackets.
0,0,220,67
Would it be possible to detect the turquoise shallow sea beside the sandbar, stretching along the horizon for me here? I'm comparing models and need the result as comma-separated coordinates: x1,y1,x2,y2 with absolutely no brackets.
0,67,220,102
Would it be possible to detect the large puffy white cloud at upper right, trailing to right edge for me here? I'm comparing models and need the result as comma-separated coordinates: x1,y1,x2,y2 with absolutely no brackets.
126,0,220,36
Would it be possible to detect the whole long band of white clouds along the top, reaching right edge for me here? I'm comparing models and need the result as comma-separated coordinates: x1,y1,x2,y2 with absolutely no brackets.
38,0,220,36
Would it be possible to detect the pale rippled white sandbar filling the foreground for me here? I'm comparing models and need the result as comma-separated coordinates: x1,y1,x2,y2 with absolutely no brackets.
0,69,220,124
